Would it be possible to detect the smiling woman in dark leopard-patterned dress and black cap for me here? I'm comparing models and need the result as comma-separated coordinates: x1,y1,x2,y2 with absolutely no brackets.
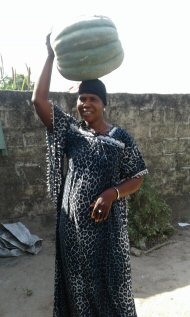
32,35,147,317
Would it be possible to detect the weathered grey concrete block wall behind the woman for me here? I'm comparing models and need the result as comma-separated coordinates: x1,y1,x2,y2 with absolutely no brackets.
0,91,190,220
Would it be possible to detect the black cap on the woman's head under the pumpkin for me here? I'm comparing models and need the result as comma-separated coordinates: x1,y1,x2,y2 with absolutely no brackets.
78,79,107,105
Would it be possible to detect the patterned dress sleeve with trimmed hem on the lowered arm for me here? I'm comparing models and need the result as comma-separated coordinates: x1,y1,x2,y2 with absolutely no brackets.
121,134,148,180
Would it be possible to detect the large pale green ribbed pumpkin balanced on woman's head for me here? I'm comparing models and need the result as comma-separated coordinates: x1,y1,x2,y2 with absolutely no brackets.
52,15,124,81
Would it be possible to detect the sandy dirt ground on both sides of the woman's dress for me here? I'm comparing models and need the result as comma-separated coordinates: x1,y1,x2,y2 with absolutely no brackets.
0,212,190,317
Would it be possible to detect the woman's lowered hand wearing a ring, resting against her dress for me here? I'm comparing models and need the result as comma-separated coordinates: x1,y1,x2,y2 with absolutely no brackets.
90,188,117,222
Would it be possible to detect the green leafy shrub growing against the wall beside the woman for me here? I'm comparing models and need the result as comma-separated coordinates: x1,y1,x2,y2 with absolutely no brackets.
128,176,174,249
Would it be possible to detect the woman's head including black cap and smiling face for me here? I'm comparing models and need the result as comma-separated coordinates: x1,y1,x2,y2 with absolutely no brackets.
77,79,107,124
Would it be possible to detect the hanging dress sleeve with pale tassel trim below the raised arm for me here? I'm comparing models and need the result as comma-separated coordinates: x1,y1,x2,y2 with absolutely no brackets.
46,106,77,203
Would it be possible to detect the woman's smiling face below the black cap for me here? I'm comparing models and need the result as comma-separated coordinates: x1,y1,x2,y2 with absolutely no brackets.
77,94,104,123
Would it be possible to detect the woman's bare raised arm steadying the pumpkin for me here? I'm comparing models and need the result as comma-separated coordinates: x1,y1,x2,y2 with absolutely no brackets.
32,34,54,129
